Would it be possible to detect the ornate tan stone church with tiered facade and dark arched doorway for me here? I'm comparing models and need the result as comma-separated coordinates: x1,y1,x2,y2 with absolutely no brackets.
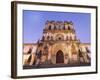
23,21,91,65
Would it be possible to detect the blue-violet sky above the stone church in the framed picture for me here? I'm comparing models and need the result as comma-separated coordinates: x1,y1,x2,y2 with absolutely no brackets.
23,10,91,43
